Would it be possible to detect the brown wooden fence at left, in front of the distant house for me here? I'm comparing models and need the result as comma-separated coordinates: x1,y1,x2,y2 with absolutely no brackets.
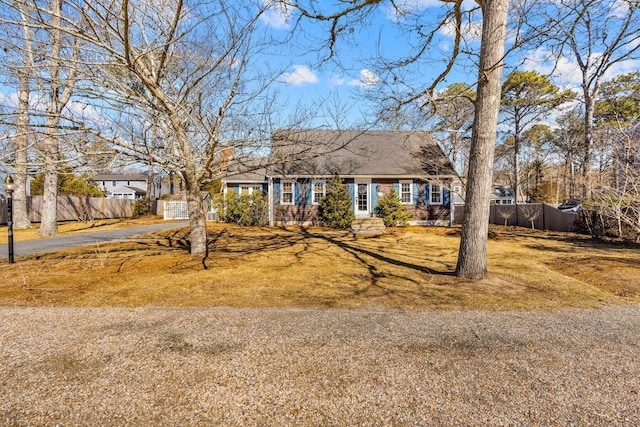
0,196,159,224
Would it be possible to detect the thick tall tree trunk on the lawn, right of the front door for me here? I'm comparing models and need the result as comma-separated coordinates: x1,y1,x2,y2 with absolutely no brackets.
456,0,509,279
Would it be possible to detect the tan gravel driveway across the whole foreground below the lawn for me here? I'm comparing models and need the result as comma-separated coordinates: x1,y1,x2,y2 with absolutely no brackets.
0,306,640,426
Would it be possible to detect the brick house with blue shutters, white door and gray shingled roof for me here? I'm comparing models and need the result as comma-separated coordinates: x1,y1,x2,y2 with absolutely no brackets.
222,130,454,225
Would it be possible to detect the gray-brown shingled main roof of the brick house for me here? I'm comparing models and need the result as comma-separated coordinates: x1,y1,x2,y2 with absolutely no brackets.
271,130,454,177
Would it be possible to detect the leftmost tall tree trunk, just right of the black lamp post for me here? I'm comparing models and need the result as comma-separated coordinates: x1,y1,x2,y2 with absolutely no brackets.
13,72,31,229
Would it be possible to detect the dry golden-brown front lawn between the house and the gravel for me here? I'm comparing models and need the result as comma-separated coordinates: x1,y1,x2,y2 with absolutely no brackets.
0,224,640,310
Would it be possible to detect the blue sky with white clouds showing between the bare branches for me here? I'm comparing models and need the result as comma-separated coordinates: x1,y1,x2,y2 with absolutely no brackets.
0,0,640,137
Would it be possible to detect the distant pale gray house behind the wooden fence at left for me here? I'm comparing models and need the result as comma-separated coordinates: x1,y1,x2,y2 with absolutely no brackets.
93,173,164,199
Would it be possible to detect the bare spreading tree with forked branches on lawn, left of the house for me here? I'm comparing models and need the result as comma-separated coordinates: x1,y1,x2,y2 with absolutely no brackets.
36,0,320,256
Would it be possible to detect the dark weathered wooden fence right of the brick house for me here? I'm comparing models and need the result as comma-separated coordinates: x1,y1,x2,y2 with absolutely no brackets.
454,203,579,232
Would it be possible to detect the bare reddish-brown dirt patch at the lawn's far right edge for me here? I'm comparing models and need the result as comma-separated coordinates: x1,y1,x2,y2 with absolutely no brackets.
548,256,640,298
